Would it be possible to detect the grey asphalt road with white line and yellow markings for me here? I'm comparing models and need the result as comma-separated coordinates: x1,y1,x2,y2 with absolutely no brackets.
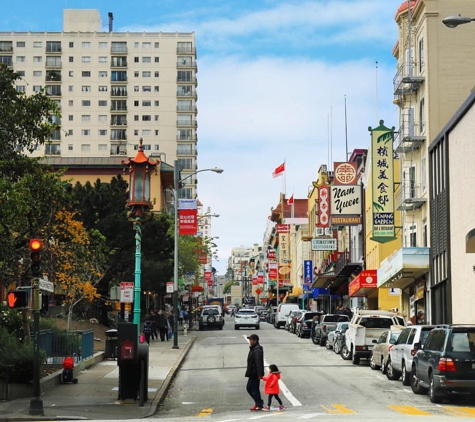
153,316,475,422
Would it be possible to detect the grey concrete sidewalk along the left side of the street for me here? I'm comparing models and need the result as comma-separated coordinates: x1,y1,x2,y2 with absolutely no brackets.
0,327,196,422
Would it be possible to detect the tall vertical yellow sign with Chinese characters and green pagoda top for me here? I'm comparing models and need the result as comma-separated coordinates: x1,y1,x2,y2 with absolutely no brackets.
370,120,396,243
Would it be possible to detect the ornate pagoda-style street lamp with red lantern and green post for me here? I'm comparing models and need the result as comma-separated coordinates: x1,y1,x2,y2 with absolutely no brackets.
122,138,158,333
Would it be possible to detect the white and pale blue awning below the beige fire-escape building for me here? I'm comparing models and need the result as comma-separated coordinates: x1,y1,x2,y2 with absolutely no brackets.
377,248,429,289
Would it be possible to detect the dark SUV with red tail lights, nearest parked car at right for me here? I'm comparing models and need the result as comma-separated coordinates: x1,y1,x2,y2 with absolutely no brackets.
411,325,475,403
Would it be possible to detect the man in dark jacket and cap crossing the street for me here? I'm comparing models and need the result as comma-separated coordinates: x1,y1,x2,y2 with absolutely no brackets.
245,334,264,412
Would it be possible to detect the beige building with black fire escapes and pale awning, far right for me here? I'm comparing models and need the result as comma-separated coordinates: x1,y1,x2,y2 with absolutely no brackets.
378,0,475,323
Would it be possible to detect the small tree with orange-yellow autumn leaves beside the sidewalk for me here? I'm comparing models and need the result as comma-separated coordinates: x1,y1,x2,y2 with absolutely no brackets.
48,210,107,331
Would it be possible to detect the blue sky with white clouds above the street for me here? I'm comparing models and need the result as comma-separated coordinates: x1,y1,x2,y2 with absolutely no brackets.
0,0,406,274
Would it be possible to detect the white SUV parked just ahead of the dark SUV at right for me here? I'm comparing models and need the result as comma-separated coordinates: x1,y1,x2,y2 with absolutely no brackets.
389,325,442,385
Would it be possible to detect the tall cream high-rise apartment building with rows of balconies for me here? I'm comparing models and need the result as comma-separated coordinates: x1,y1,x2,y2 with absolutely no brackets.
0,9,197,198
